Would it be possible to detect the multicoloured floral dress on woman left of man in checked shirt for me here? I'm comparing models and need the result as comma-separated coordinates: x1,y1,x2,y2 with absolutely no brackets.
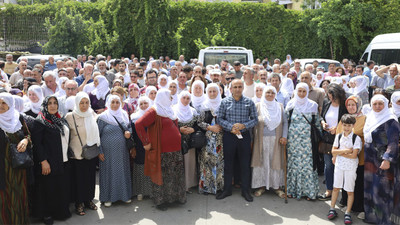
198,111,224,194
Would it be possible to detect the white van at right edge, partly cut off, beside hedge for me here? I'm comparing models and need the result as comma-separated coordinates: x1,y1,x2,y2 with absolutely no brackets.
361,33,400,65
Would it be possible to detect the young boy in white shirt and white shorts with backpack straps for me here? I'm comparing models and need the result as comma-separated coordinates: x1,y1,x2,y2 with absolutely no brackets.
328,114,362,224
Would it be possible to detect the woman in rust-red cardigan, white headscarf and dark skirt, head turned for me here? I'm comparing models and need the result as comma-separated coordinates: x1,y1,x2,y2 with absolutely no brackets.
135,89,186,211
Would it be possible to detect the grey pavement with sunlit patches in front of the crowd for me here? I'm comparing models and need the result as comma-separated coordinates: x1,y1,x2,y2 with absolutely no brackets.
32,177,364,225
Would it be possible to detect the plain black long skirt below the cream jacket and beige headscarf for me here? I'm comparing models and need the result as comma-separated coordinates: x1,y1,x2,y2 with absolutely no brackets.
71,157,98,204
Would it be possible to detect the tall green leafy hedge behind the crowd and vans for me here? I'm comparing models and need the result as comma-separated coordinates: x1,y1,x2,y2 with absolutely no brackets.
0,0,400,60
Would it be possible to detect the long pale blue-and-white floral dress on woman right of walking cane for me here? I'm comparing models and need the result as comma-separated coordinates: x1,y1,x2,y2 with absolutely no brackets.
287,110,320,199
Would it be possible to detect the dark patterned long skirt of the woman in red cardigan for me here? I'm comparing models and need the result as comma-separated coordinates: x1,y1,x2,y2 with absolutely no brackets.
152,151,186,205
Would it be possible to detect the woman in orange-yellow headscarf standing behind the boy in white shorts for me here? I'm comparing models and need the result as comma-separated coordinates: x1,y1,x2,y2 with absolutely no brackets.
333,95,366,216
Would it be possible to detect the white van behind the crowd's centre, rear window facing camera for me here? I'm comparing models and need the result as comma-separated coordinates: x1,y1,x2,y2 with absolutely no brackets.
198,46,254,66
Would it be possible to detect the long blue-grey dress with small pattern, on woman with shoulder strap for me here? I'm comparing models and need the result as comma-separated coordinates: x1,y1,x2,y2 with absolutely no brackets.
97,119,132,202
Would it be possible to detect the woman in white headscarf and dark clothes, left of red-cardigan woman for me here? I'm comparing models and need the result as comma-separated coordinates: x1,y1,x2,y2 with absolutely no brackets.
131,96,151,200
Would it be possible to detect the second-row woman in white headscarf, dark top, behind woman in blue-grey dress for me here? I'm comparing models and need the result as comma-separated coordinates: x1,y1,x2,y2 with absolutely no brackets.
89,75,110,114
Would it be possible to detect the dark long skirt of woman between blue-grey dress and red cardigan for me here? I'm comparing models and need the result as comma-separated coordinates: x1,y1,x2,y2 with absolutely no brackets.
132,163,152,197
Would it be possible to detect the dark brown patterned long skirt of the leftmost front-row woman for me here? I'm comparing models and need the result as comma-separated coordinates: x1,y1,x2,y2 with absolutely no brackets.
0,143,29,224
